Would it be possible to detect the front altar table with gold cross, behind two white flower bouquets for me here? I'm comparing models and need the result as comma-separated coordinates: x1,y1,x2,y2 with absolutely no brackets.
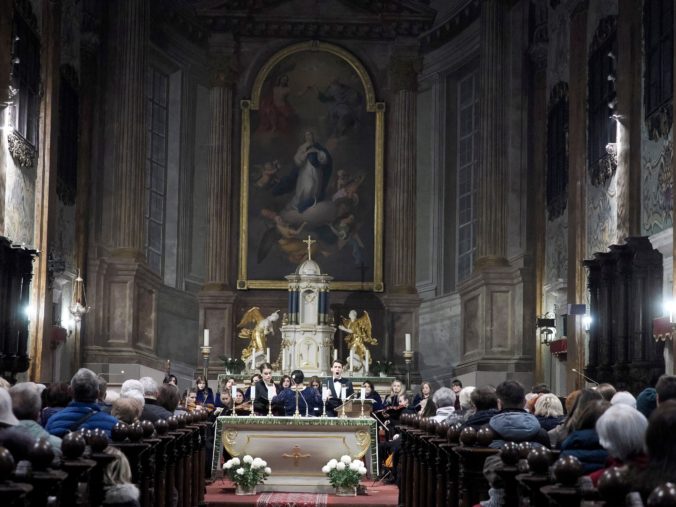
212,417,378,493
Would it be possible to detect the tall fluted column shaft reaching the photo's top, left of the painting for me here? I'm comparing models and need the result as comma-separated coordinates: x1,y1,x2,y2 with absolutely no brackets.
112,0,149,257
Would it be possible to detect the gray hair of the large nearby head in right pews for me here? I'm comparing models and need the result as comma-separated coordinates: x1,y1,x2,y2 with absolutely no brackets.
596,403,648,461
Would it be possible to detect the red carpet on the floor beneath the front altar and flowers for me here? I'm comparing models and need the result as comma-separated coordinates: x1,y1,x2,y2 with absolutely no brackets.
204,481,399,507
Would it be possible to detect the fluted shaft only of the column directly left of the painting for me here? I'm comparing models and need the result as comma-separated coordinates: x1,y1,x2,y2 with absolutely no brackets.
206,83,232,288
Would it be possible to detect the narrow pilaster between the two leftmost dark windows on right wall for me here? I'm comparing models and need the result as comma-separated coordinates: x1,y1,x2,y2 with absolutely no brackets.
566,2,589,392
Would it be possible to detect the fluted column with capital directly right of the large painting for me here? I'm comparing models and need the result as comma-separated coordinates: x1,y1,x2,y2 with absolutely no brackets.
386,56,419,292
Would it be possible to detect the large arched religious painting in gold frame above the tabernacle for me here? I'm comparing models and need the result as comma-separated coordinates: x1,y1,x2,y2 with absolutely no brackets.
237,42,385,291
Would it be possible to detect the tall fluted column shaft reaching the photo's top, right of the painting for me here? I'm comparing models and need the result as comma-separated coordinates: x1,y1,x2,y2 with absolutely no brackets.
476,0,508,269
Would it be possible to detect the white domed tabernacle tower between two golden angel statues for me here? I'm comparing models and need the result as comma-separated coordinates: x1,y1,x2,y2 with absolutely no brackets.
280,253,336,378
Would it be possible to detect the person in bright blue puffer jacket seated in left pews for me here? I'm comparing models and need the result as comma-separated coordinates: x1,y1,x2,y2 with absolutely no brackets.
46,368,117,437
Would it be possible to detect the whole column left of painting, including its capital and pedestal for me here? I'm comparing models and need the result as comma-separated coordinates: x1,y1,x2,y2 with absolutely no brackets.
197,53,239,374
